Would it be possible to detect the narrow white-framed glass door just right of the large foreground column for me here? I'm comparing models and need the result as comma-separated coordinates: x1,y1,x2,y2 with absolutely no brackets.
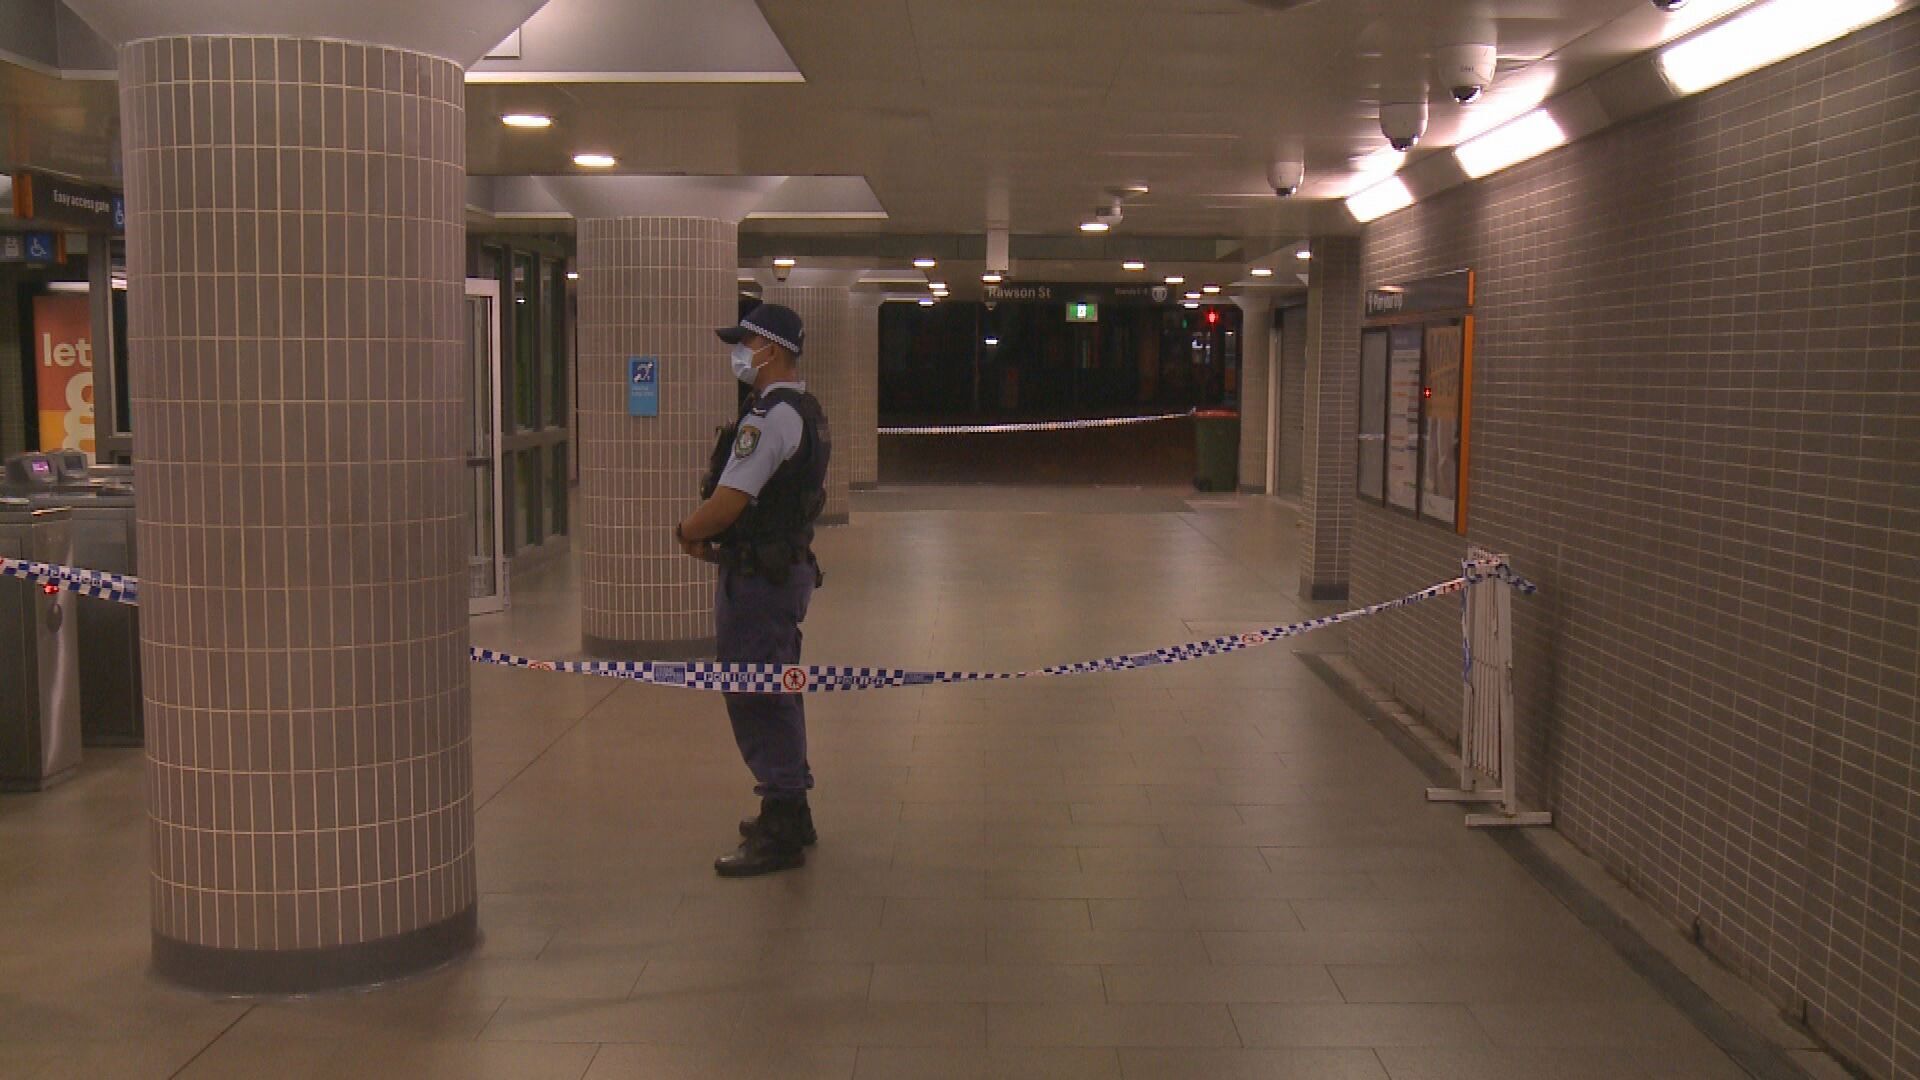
461,277,507,615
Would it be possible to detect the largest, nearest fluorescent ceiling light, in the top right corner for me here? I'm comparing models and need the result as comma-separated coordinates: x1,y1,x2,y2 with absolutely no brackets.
1659,0,1899,94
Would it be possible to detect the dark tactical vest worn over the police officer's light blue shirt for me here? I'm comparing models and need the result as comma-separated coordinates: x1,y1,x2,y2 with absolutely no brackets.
701,386,833,584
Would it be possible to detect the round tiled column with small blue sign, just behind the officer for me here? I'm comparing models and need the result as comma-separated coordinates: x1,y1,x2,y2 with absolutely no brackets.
580,217,733,659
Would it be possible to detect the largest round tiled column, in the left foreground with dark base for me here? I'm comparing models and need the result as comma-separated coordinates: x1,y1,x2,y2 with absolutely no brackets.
121,37,474,992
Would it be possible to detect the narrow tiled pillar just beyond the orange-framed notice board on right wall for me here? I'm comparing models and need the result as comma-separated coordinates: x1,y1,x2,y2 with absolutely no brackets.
1300,236,1363,601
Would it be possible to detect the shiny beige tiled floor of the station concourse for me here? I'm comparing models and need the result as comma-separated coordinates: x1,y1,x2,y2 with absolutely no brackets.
0,488,1743,1080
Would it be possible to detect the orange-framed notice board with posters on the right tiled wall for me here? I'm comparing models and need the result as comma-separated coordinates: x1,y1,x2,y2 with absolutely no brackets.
1356,271,1475,534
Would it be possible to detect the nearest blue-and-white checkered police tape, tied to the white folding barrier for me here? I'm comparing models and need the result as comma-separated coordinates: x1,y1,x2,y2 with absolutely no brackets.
0,557,1489,694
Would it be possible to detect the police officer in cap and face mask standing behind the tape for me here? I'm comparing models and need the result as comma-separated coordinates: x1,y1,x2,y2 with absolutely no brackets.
674,304,833,878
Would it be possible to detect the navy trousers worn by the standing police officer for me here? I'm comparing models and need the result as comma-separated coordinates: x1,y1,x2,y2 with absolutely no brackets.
714,563,814,799
